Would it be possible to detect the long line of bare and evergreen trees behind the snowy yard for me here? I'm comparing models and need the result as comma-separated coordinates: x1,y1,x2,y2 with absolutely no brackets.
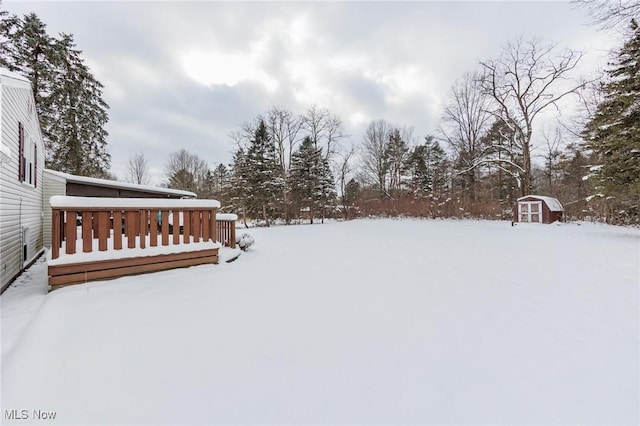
158,20,640,224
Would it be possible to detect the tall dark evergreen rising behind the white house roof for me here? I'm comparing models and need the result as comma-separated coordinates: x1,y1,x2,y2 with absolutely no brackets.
0,13,111,178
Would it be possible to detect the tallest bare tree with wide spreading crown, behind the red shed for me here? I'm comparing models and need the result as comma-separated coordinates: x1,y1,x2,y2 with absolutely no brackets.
480,38,586,195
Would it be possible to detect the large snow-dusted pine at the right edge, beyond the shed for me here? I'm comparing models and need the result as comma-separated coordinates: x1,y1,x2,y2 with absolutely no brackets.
584,20,640,221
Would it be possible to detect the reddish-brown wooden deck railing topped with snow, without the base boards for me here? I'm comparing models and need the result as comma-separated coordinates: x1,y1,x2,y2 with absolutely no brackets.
50,196,235,259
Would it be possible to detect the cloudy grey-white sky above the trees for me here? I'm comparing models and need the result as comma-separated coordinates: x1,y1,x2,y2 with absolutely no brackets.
3,0,618,184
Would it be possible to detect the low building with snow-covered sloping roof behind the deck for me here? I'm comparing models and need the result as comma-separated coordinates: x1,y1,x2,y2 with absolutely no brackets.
43,169,196,247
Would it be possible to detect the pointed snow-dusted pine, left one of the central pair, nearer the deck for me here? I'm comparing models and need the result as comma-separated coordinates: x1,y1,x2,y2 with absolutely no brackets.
245,120,285,226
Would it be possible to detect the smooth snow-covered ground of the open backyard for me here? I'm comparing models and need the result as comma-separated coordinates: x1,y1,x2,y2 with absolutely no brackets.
0,220,640,425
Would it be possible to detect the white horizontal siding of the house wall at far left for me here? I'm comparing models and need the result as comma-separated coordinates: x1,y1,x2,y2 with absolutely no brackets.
0,71,44,289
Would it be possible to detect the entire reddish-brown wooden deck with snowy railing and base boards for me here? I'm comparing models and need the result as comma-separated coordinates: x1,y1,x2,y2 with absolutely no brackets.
48,197,235,290
